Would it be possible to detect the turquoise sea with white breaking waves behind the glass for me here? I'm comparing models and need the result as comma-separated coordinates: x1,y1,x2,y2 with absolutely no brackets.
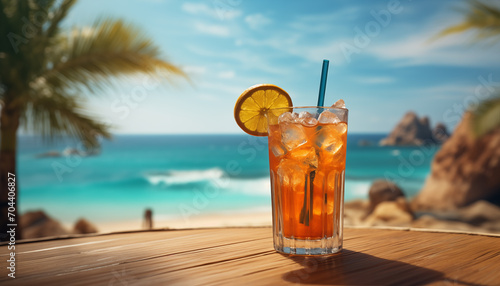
18,134,437,225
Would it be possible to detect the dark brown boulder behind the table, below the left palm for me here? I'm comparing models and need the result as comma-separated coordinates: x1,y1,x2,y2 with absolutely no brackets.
20,211,69,239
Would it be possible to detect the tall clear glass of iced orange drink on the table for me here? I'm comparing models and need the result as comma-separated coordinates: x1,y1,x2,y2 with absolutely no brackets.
267,107,348,255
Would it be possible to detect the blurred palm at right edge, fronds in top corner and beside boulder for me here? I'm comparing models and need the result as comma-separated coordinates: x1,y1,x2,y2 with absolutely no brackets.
438,0,500,137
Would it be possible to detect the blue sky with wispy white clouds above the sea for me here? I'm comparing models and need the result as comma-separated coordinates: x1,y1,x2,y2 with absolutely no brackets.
64,0,500,134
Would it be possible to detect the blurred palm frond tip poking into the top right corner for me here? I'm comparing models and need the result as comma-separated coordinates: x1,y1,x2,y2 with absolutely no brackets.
433,0,500,39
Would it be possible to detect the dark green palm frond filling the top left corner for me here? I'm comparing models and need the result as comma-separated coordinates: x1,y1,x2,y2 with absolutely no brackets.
0,0,75,97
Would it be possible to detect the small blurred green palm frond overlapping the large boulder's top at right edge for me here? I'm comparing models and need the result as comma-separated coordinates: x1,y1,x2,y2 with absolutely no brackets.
472,95,500,137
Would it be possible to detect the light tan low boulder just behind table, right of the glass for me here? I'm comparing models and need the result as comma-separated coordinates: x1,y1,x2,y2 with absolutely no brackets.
365,197,414,226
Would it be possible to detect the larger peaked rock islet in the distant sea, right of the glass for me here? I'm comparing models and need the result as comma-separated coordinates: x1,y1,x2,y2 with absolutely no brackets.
380,111,436,146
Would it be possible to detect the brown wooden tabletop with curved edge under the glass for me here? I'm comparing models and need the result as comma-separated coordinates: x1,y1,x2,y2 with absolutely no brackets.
0,228,500,285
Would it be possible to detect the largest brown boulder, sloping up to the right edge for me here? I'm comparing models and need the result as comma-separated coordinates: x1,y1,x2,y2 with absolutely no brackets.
412,113,500,210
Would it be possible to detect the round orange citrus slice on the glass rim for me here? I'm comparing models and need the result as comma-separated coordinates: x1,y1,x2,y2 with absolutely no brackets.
234,84,292,136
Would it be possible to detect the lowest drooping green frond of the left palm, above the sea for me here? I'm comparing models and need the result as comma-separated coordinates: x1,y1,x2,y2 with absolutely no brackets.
21,91,111,148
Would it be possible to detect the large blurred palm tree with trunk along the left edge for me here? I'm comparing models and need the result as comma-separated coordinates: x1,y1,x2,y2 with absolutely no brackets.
0,0,185,239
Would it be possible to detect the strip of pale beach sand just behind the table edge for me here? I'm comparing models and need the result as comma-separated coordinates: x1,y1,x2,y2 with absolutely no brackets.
57,200,500,237
